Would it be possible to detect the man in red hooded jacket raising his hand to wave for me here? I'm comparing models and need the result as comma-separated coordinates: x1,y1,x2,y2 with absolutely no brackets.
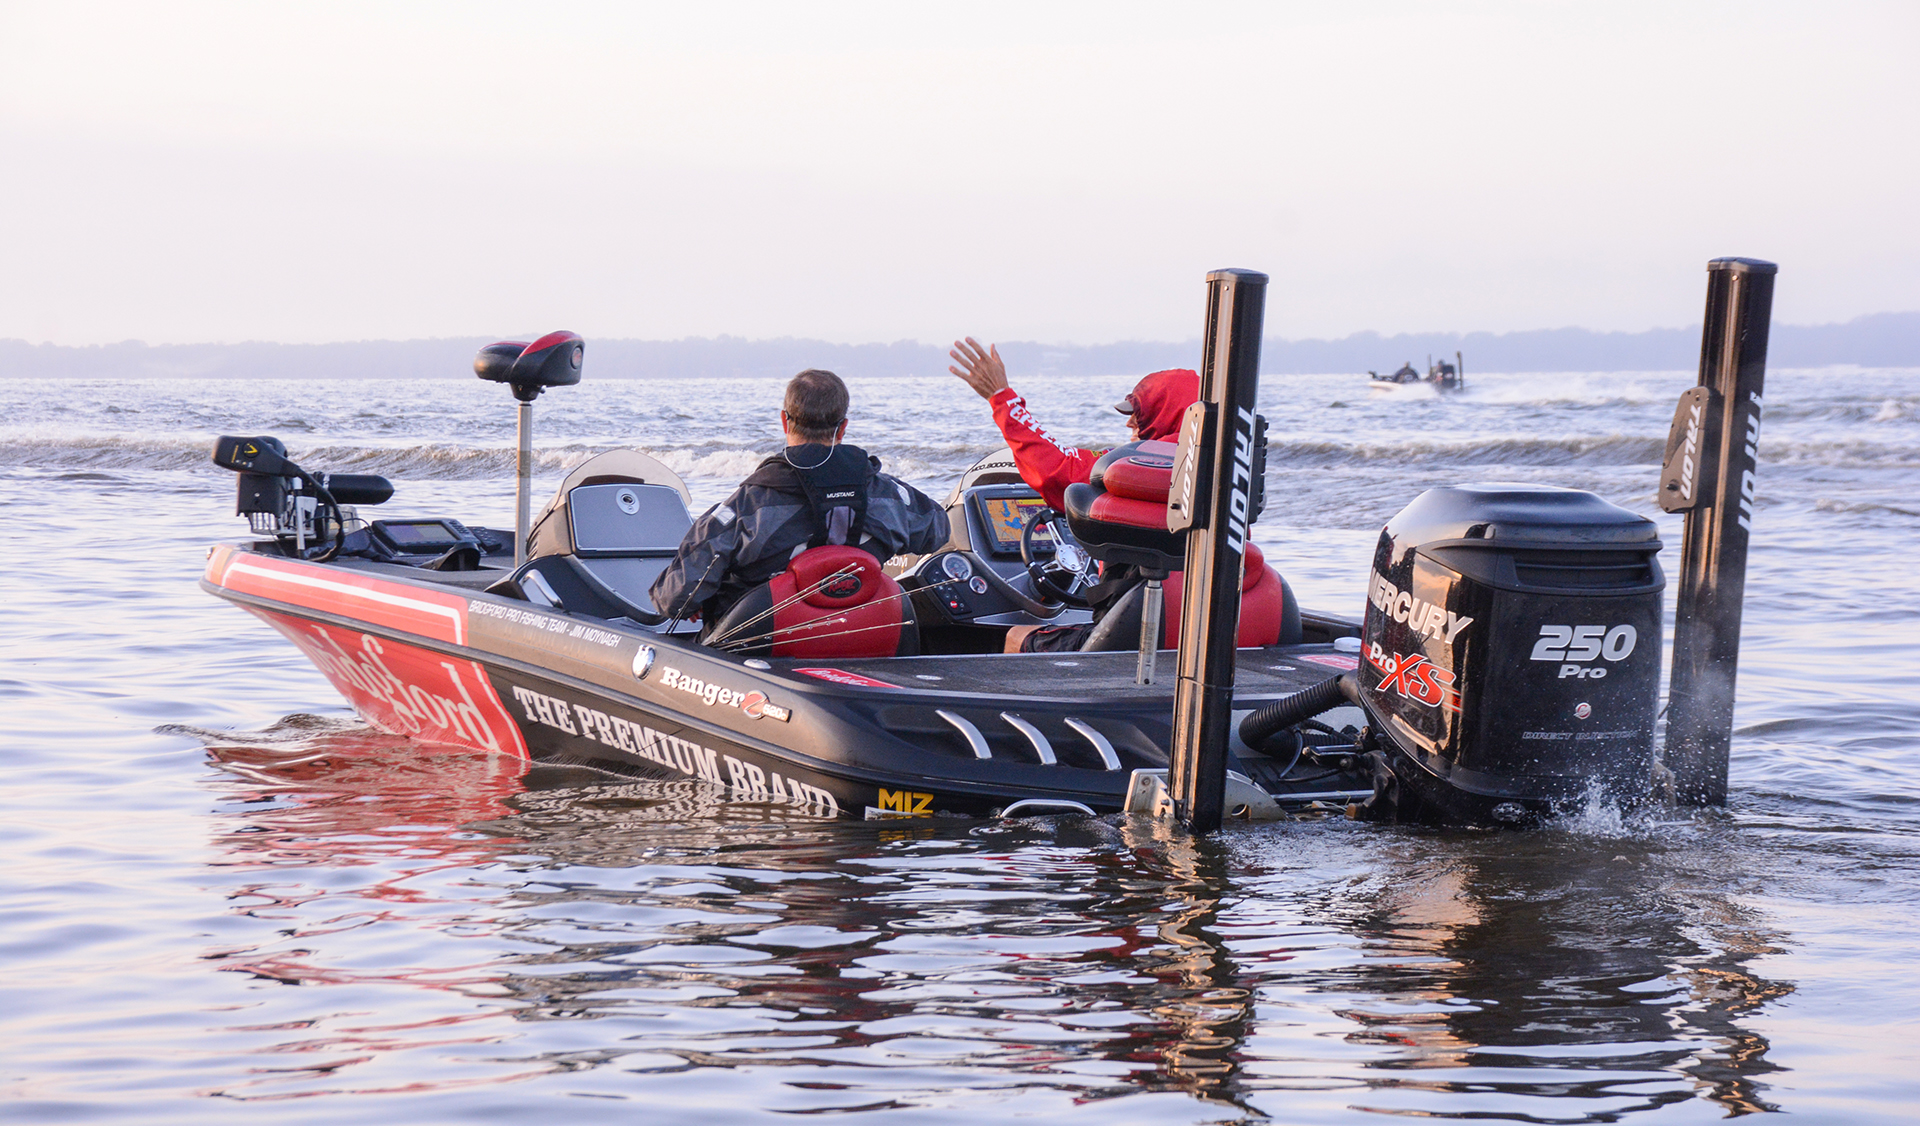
947,336,1200,653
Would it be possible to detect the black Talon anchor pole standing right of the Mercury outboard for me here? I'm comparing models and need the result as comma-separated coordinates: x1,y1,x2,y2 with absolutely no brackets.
1659,257,1780,805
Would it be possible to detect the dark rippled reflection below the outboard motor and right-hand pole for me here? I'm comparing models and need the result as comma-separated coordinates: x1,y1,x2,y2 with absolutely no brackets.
1348,830,1793,1118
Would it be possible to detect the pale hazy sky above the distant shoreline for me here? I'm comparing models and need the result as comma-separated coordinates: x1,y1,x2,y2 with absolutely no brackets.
0,0,1920,344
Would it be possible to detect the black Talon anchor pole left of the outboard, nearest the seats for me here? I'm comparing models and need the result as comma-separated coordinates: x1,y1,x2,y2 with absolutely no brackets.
1167,269,1267,832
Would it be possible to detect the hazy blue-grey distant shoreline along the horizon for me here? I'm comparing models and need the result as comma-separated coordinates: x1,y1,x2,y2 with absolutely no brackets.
0,311,1920,379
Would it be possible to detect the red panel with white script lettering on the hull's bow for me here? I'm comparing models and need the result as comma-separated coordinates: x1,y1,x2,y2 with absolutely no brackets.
246,605,528,759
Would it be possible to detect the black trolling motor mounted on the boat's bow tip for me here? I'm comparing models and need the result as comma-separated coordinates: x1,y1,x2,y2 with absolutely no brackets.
213,434,394,563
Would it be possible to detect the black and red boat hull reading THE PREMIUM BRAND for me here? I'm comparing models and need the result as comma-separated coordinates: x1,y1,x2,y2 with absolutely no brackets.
202,546,1344,817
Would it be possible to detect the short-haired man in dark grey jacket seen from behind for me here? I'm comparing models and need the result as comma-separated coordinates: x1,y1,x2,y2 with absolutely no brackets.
653,369,947,624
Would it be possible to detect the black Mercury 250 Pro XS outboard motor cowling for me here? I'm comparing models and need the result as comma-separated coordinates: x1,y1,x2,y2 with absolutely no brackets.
1359,484,1667,824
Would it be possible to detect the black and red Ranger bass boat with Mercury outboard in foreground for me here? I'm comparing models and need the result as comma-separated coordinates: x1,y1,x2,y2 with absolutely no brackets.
202,263,1774,826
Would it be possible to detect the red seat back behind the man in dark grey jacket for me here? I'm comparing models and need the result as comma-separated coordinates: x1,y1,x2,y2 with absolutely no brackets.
703,546,920,661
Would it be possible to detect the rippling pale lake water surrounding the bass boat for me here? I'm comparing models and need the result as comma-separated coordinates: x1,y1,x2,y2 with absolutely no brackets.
0,363,1920,1124
